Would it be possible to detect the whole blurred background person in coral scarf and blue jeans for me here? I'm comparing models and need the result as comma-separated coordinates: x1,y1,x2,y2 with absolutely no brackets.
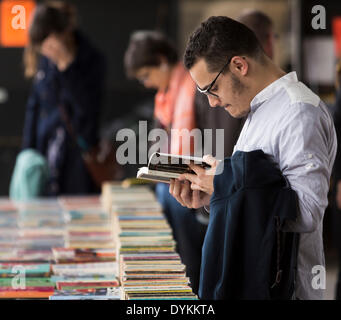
124,31,206,292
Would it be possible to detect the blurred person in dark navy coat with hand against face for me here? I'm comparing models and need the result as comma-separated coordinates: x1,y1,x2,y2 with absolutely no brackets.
23,1,105,196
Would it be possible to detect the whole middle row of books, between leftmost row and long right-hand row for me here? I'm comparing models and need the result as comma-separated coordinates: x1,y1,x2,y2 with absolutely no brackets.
50,196,121,300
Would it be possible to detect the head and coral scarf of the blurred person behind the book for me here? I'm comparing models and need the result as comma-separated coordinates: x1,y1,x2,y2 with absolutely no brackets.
124,31,196,155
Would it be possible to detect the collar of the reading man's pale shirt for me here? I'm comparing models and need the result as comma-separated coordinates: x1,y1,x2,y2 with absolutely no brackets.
250,71,298,112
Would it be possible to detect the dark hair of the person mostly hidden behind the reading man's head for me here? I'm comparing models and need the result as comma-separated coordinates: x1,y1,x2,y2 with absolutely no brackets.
237,10,273,44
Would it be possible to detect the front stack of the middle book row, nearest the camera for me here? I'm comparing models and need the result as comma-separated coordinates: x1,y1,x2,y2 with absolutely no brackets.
50,248,121,300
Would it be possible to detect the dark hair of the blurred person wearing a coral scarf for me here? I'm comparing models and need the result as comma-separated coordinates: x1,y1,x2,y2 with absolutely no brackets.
124,31,178,77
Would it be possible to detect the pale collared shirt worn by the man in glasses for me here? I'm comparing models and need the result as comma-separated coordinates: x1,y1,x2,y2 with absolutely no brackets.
234,72,337,299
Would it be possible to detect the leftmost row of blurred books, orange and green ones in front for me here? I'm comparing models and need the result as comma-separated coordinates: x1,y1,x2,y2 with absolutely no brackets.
0,199,65,299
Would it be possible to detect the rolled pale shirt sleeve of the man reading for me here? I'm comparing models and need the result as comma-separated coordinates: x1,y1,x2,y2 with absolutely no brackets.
277,103,336,233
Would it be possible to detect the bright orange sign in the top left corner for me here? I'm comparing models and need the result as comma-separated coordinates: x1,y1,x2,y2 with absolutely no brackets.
0,0,36,47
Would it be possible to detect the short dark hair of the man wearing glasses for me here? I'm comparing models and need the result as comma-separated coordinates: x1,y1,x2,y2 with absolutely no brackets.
184,16,264,72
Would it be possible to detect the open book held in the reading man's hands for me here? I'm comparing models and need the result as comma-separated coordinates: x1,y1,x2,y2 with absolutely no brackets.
137,152,211,183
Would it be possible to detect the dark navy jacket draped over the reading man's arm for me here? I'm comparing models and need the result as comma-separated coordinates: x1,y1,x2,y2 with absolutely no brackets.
199,150,298,300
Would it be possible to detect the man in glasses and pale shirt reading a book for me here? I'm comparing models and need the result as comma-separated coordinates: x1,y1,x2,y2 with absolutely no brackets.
170,16,337,299
